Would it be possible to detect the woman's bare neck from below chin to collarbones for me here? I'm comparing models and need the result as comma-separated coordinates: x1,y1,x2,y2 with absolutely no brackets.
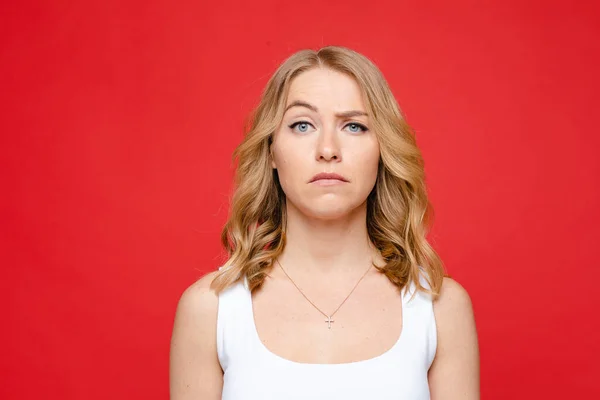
279,203,377,275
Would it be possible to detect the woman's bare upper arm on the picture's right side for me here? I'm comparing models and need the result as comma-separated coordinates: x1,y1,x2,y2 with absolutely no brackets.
429,278,479,400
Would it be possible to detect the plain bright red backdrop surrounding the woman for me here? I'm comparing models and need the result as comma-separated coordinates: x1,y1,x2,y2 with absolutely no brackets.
0,0,600,399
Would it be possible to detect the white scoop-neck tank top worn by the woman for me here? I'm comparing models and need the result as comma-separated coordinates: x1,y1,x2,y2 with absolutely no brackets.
217,280,437,400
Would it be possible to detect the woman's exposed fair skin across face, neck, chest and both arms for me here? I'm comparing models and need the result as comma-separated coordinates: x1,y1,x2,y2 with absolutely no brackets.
170,68,479,400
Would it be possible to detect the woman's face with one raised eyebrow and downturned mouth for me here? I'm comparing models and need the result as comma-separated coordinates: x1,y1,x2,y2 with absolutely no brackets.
271,68,379,219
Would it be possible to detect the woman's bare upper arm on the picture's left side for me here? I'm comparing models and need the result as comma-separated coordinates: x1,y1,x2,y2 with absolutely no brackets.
169,272,223,400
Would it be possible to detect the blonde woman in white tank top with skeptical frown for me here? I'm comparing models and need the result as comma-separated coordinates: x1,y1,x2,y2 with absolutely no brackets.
170,46,479,400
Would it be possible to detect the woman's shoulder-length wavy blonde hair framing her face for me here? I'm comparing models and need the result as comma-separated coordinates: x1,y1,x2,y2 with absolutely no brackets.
211,46,444,297
